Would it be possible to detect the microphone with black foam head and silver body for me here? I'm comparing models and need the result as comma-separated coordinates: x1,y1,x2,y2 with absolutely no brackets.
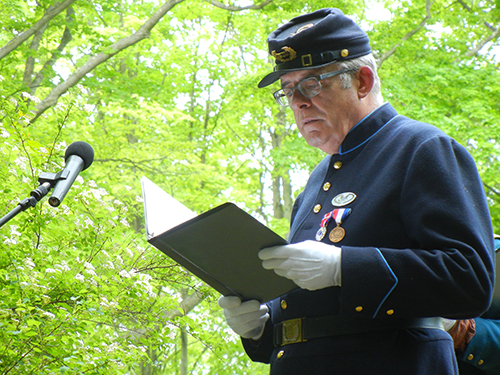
49,141,94,207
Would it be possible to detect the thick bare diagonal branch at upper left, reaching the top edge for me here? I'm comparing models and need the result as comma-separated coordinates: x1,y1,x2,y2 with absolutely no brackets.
30,0,184,123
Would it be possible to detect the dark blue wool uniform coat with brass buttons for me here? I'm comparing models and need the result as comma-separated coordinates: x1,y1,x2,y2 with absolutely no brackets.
243,103,493,375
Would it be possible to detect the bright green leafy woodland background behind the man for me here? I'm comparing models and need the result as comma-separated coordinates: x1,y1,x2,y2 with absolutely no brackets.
0,0,500,374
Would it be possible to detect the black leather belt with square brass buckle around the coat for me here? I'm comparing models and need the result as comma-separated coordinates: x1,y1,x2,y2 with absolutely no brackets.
274,315,443,347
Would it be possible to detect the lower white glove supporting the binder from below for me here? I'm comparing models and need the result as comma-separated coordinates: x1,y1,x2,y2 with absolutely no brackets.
219,296,269,340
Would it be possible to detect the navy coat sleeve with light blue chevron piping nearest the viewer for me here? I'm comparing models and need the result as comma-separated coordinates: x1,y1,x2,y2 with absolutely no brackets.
341,136,493,319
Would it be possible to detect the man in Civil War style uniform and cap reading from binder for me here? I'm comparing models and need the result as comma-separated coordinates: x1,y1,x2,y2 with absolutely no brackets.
219,9,493,375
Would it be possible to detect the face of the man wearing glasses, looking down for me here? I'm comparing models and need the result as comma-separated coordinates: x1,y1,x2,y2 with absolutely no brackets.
281,66,360,154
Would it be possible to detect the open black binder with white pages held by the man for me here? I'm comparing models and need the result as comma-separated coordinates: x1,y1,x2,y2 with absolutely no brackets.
141,178,297,302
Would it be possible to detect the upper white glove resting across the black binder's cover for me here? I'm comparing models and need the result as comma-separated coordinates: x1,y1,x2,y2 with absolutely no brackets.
259,241,342,290
